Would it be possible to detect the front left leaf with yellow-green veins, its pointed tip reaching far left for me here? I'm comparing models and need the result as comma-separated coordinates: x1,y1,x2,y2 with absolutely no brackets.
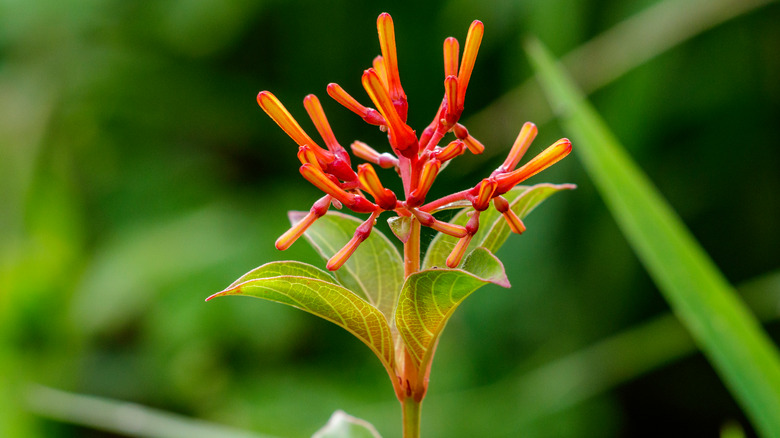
206,262,394,375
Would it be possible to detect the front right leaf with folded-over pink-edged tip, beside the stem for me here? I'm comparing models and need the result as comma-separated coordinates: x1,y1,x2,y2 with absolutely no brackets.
395,248,509,370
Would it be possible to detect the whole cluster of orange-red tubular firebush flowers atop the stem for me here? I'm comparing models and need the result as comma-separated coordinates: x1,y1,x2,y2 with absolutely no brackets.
257,13,571,270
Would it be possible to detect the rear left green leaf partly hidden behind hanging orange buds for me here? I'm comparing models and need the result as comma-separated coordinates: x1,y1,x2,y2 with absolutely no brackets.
289,211,404,322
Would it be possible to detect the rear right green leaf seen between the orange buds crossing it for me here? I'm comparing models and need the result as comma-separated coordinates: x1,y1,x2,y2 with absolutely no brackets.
423,184,576,269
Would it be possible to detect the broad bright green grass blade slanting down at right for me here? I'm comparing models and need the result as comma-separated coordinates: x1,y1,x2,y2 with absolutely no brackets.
528,40,780,437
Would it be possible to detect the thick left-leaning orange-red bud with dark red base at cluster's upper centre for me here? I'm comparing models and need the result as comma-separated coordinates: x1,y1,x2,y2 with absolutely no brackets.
362,68,418,158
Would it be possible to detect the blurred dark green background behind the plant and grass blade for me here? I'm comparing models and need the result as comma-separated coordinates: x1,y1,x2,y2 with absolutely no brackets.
0,0,780,437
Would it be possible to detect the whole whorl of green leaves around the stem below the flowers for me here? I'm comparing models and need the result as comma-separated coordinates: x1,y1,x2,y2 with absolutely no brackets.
208,184,574,399
